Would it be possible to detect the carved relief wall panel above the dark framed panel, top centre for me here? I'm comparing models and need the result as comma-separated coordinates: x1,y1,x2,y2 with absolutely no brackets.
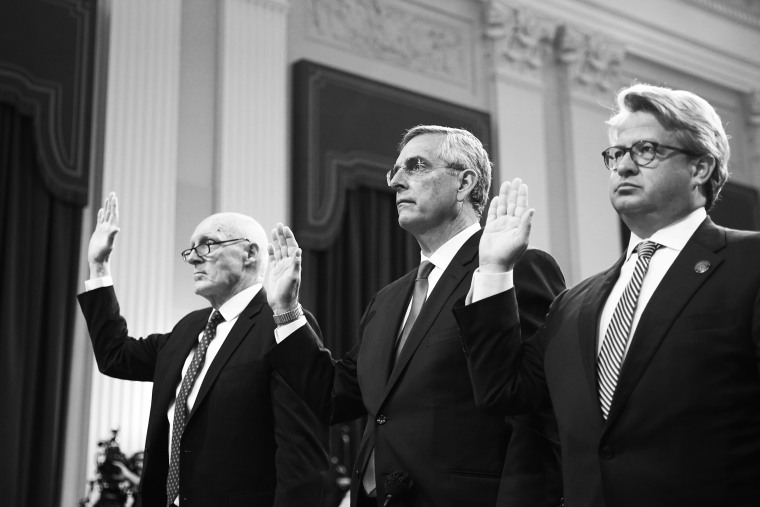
308,0,474,88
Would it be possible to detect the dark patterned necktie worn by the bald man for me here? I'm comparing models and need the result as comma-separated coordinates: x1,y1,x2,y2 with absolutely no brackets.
166,310,224,505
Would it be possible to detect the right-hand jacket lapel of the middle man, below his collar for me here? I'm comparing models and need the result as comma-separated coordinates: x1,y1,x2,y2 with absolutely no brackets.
383,232,482,399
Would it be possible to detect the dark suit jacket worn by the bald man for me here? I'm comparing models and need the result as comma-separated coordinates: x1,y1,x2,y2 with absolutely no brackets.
78,287,328,507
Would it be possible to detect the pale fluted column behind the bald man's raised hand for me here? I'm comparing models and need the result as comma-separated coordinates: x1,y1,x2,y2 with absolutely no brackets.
88,0,181,468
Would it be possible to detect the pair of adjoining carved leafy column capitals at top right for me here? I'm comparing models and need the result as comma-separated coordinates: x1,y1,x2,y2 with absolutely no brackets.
486,0,625,95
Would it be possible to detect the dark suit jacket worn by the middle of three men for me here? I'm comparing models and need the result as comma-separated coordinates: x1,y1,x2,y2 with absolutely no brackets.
268,233,564,507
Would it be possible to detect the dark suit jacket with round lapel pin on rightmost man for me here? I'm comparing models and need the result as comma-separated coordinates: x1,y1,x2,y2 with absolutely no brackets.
456,218,760,507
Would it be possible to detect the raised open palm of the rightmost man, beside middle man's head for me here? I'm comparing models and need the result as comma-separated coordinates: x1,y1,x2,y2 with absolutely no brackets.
480,178,533,272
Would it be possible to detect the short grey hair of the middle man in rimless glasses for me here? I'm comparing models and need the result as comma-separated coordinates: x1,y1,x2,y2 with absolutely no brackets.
398,125,493,217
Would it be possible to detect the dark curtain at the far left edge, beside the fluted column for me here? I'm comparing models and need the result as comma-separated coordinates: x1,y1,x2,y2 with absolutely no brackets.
0,104,82,507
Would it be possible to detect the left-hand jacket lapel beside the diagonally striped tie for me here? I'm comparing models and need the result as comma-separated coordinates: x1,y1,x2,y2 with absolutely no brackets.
578,253,625,417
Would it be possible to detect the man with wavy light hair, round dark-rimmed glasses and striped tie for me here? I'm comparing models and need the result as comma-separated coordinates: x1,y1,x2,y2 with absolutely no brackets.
456,84,760,507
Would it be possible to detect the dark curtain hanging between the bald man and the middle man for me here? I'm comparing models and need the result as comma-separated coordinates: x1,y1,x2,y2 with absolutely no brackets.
295,187,420,490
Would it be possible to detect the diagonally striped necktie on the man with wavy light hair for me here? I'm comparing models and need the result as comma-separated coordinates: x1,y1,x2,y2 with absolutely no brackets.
596,241,661,419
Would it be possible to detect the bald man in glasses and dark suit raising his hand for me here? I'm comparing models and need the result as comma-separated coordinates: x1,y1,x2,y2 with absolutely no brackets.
79,193,328,507
